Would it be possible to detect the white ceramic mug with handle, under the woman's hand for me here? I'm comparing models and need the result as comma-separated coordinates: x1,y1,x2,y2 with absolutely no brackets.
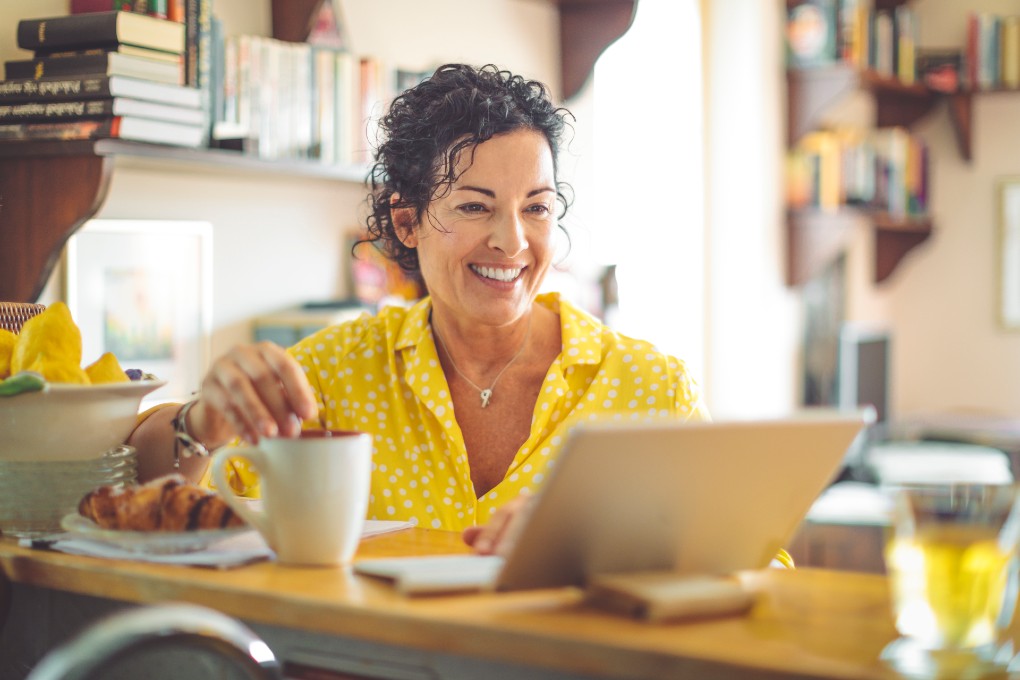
212,430,372,566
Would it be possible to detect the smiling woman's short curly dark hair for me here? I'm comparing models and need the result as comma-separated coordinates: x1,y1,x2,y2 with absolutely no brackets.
363,64,572,274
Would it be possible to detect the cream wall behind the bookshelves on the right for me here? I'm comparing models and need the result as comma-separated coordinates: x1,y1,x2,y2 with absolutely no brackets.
849,0,1020,417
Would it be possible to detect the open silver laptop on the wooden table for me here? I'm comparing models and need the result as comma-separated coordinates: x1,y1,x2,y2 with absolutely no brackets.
354,410,869,594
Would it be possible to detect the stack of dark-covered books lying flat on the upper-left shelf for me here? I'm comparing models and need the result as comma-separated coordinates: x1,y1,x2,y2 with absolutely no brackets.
0,11,208,147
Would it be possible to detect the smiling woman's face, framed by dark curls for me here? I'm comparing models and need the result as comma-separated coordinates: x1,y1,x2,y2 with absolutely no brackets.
407,129,556,326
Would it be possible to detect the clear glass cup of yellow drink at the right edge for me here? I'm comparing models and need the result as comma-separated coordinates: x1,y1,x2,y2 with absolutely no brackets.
881,483,1020,679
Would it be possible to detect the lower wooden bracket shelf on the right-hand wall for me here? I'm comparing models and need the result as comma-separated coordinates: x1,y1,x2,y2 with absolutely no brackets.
786,207,932,285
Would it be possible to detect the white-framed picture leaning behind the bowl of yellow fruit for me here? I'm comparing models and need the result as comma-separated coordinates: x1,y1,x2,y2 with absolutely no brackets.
65,219,212,406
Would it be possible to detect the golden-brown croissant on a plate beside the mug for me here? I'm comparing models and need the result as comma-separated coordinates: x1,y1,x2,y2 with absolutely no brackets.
78,475,244,531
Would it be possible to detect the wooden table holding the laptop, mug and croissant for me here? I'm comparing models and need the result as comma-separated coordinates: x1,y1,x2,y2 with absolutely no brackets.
0,528,909,680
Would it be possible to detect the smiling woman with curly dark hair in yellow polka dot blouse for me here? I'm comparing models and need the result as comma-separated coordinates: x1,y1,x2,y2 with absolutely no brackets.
130,64,704,552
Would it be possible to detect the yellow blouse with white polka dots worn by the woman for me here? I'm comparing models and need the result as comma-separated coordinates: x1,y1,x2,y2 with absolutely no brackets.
290,294,707,530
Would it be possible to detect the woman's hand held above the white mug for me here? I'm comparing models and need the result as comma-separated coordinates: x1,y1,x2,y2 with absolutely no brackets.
189,342,318,449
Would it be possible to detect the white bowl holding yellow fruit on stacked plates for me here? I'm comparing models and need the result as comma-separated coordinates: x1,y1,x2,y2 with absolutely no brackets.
0,380,166,462
